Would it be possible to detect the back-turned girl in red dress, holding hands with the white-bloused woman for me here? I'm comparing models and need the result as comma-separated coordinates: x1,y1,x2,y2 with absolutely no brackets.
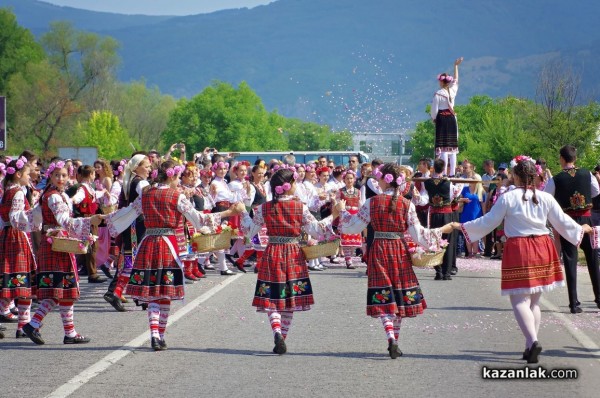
338,163,451,359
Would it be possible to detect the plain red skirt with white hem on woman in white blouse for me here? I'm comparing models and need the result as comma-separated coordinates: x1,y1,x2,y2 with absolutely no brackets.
500,235,565,296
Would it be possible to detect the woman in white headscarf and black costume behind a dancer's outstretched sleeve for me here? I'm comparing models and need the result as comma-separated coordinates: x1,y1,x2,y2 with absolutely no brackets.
104,154,150,312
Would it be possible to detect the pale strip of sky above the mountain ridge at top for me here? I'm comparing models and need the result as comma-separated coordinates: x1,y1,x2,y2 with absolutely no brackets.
41,0,274,15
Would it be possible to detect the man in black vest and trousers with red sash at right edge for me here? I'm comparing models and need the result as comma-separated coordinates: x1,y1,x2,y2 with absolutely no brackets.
544,145,600,314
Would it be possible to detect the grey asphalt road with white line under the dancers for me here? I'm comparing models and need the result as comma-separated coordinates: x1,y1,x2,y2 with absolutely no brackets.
0,259,600,398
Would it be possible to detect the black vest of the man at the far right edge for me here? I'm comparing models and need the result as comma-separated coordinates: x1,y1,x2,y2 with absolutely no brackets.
553,168,592,211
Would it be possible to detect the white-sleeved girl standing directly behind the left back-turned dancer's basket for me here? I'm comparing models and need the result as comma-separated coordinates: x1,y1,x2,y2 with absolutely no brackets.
210,161,249,275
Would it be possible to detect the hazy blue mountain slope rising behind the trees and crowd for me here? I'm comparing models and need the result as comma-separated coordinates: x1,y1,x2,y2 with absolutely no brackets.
0,0,600,131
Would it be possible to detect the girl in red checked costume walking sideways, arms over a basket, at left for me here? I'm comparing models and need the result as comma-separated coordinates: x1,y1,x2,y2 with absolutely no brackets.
23,160,102,344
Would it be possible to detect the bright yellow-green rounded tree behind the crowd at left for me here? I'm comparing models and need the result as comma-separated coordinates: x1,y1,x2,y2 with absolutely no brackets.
77,111,134,159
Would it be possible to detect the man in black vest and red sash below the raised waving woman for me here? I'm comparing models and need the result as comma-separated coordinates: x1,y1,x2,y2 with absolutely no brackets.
422,158,457,281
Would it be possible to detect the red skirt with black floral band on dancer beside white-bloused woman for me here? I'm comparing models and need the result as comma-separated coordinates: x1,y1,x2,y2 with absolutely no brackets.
367,239,427,317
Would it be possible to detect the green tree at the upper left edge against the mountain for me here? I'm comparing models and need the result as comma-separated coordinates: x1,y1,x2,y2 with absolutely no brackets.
0,8,45,94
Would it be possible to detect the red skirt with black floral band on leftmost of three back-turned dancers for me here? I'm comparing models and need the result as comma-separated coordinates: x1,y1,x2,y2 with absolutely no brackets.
125,235,184,301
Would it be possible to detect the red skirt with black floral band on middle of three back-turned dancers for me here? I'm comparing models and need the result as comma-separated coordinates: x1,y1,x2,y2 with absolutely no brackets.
252,243,315,312
